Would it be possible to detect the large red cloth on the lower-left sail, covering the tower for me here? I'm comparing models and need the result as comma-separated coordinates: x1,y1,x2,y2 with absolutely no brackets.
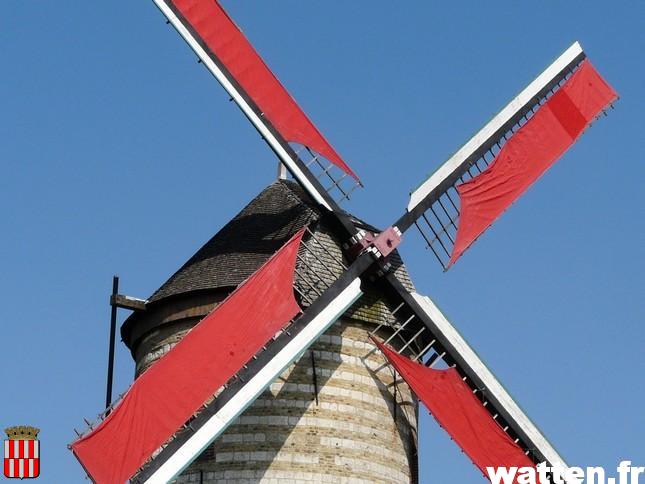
72,231,303,484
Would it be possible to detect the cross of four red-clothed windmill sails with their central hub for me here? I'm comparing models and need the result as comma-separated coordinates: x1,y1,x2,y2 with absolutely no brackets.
71,0,617,483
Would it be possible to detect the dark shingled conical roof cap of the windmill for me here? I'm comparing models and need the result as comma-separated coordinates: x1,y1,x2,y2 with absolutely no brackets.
122,180,413,344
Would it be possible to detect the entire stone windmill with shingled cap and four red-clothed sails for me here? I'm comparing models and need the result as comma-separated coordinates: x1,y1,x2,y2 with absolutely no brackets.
70,0,617,484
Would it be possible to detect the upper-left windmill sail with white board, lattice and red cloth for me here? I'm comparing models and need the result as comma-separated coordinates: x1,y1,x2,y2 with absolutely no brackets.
154,0,360,211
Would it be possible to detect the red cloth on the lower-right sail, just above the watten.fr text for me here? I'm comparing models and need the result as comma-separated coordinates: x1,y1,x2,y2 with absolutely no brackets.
374,340,535,482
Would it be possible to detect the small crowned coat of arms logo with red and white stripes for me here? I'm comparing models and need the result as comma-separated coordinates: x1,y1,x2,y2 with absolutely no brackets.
4,425,40,479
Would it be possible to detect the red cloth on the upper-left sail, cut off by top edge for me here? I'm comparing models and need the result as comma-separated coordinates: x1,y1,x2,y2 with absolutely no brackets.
168,0,358,181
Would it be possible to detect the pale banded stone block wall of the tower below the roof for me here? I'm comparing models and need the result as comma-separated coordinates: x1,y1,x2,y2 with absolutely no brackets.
137,319,418,484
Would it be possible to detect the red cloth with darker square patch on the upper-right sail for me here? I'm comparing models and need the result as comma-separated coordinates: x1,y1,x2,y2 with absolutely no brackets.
448,60,617,266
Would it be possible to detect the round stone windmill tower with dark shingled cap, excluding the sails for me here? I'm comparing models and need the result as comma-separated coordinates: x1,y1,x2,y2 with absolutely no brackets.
121,180,418,484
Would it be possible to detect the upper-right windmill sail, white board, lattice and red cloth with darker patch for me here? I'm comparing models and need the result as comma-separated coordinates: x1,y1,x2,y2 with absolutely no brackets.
397,42,617,269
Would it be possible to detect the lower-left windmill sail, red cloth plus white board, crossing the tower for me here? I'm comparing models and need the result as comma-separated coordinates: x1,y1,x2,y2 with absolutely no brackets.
71,229,372,483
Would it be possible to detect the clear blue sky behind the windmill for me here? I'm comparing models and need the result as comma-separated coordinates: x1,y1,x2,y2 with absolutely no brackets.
0,0,645,484
